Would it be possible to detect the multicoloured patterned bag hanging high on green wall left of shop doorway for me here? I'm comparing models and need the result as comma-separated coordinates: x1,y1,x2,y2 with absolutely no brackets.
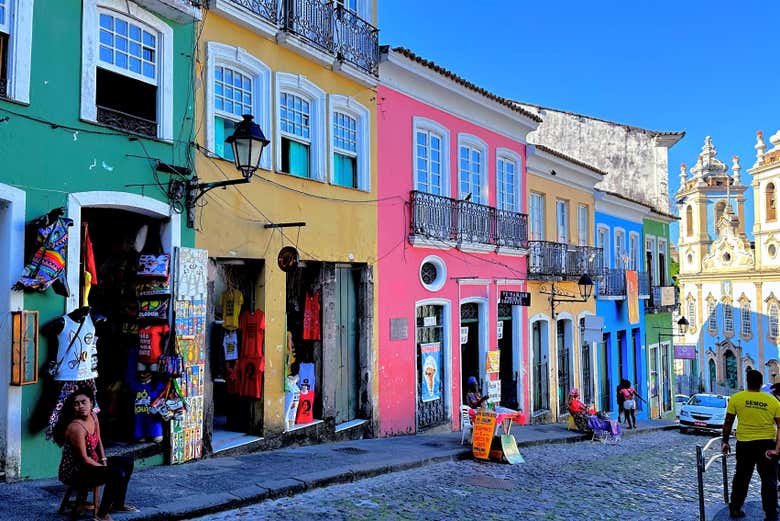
14,217,73,296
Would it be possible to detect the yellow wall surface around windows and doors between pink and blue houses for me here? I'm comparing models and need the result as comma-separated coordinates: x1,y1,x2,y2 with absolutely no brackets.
527,175,596,419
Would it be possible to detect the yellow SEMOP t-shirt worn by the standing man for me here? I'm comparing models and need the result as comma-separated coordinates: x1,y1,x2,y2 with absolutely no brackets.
726,391,780,441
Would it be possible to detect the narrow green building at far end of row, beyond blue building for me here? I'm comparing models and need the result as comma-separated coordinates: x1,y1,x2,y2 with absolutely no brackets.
642,210,678,418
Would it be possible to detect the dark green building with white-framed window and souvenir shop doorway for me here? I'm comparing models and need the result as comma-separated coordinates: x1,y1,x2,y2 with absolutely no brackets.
0,0,201,479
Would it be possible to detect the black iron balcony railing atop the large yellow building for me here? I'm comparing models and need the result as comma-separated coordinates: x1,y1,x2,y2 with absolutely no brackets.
229,0,379,76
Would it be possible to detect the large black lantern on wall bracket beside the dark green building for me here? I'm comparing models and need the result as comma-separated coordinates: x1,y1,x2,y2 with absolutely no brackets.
166,114,270,228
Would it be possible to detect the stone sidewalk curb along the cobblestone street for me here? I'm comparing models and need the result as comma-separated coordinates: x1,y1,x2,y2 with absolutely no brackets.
121,425,677,521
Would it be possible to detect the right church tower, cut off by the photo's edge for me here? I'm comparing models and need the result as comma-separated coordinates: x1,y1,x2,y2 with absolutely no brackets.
748,131,780,271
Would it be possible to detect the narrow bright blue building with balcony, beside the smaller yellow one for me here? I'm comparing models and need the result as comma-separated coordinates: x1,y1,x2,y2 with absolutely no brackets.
595,190,651,419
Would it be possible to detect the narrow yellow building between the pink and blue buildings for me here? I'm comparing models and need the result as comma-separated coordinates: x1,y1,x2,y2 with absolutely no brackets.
528,145,605,422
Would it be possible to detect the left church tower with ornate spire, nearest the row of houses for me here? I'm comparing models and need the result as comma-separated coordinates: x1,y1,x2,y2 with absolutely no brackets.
675,136,748,275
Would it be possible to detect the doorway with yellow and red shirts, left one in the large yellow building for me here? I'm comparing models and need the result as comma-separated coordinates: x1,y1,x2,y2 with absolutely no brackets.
209,259,265,452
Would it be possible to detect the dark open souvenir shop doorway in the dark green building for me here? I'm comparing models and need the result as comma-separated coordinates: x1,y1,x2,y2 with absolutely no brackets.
80,208,171,446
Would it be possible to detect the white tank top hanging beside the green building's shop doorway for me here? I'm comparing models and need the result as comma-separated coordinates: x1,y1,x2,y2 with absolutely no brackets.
54,314,97,382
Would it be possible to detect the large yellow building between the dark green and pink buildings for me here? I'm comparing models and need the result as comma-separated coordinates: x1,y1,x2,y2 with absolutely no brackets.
194,0,379,452
